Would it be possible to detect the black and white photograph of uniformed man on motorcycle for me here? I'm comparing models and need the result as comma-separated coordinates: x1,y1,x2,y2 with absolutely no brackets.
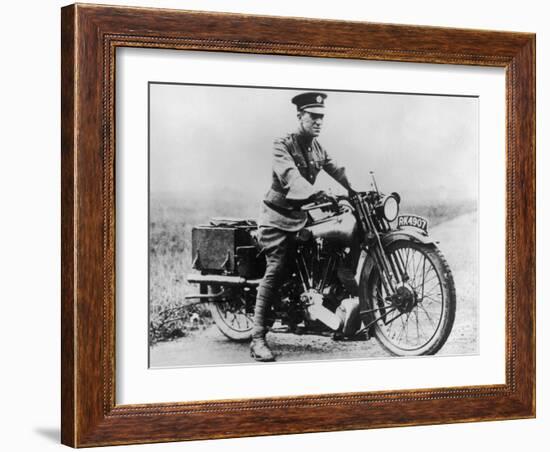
147,81,479,368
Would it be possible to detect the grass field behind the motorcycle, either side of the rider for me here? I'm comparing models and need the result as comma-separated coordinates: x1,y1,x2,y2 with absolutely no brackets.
149,193,476,343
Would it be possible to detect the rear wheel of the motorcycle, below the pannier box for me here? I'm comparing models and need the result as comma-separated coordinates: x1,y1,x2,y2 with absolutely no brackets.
208,286,254,342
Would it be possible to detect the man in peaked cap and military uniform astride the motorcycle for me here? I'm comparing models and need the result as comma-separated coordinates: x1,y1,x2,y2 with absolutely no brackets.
250,92,358,361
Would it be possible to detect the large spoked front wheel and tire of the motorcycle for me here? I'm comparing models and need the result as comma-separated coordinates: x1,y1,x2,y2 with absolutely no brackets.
360,240,456,356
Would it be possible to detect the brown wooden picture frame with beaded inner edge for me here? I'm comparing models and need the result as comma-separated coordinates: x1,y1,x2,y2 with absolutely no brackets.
61,4,535,447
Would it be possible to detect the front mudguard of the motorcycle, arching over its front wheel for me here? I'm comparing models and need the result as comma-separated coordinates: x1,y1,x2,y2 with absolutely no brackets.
358,229,437,324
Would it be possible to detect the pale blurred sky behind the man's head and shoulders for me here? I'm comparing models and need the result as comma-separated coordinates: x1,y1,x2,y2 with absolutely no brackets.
149,84,478,206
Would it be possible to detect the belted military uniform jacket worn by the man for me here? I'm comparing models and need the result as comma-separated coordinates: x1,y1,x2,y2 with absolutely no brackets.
259,133,350,231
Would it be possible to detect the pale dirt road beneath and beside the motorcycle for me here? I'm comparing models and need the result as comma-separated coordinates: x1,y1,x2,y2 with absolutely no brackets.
150,214,478,367
